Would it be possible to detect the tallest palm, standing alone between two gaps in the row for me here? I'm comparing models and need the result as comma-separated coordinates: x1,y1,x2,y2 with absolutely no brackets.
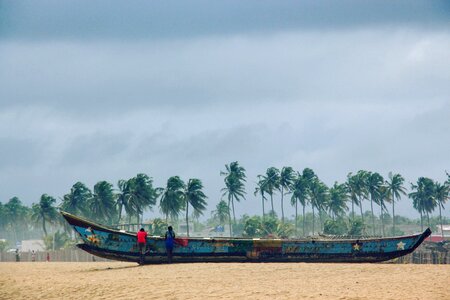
220,161,246,234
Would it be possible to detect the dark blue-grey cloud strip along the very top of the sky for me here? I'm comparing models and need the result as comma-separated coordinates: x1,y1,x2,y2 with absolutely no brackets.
0,0,450,40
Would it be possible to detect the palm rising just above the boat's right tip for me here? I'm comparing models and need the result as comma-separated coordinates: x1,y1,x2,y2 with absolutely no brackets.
408,177,436,231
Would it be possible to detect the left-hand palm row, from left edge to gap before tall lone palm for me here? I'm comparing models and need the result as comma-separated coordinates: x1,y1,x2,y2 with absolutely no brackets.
0,174,207,239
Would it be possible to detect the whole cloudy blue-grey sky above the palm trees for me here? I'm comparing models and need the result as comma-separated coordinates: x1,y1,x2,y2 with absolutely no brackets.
0,0,450,217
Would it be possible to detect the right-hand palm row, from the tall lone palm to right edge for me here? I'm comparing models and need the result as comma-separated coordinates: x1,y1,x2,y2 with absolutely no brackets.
221,162,450,235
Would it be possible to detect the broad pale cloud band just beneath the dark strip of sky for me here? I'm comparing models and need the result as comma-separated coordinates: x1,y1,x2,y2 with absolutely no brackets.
0,29,450,115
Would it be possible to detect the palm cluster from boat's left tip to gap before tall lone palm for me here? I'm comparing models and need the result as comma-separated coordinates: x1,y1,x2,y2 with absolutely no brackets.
60,174,207,236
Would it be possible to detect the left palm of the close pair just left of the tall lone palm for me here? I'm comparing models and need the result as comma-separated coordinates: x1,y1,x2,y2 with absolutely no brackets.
159,176,185,223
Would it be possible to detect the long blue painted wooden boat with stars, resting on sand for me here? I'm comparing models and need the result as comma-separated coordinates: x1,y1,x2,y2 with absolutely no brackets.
61,212,431,264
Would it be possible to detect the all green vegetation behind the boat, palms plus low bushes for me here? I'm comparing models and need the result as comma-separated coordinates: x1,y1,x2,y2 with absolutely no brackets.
0,166,450,250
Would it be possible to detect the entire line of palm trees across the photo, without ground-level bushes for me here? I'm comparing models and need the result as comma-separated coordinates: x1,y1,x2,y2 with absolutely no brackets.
0,165,450,245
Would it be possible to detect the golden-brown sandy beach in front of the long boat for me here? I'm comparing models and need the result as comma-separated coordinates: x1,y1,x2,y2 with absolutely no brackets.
0,262,450,300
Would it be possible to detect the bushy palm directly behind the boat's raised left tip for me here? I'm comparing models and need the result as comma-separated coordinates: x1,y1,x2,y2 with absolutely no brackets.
61,182,92,217
